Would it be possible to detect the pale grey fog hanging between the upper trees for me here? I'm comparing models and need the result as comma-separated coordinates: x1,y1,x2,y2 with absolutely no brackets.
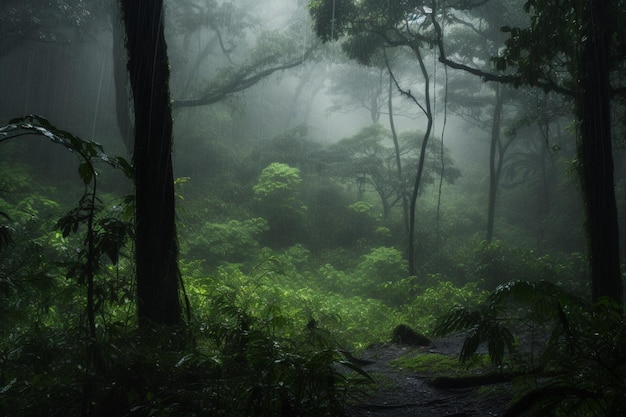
0,1,596,256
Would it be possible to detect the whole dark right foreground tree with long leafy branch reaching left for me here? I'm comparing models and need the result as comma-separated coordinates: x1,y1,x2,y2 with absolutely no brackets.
431,0,626,306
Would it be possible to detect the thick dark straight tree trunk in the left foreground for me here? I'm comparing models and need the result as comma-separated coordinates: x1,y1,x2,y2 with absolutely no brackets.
121,0,181,326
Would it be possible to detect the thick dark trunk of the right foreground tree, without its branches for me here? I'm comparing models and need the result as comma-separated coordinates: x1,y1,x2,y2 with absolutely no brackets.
577,0,623,305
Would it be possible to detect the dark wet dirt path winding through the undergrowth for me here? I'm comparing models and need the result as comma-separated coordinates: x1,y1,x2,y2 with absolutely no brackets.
346,336,511,417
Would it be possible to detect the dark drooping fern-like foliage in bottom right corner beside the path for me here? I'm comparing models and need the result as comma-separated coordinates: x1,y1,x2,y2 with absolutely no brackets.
435,281,626,417
